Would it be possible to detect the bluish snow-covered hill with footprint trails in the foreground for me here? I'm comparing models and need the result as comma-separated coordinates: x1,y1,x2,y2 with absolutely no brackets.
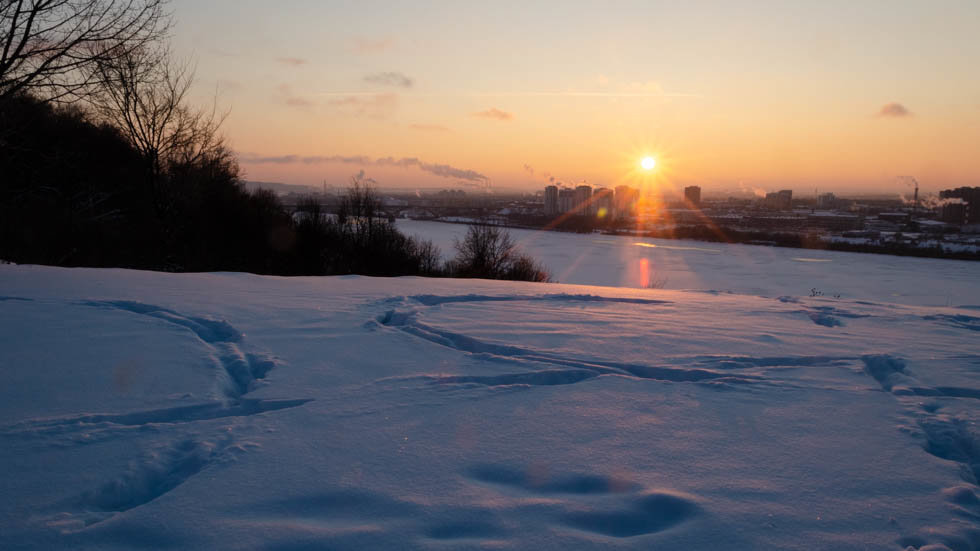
0,265,980,551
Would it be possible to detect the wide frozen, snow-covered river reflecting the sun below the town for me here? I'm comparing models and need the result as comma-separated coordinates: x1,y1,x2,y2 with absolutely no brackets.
398,220,980,306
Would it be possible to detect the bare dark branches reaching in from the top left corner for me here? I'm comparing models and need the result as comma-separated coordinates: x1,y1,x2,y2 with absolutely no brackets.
0,0,170,100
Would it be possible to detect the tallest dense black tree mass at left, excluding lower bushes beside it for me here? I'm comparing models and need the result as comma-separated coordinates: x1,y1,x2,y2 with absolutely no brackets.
0,95,290,273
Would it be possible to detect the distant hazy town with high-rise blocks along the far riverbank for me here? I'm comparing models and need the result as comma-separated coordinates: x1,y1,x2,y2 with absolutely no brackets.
250,181,980,260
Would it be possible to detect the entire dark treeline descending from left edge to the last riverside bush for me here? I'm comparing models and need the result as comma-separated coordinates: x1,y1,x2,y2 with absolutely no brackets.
0,95,549,281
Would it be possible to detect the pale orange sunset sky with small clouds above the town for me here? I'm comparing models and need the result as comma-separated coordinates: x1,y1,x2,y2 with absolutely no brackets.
172,0,980,194
